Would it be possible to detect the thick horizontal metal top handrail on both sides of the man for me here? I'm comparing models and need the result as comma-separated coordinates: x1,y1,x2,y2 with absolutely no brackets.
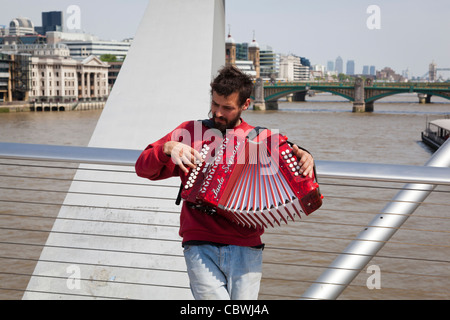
0,142,450,185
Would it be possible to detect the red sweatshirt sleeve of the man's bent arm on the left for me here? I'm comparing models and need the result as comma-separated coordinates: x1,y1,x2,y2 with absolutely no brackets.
135,127,180,180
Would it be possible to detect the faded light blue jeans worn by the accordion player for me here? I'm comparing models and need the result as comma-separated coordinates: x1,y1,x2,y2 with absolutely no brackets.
184,244,262,300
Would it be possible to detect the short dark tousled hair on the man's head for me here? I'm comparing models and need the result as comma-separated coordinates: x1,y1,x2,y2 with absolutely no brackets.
211,66,253,106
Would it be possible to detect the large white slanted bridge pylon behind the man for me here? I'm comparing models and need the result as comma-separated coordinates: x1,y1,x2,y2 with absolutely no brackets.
23,0,225,299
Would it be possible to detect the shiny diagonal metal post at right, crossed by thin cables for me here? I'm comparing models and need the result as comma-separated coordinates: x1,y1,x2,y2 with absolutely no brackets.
301,141,450,300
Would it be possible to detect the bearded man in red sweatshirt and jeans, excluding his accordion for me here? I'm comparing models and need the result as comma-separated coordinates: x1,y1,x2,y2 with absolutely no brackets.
135,66,314,300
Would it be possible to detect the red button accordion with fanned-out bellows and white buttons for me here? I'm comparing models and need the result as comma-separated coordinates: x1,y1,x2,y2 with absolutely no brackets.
181,130,322,228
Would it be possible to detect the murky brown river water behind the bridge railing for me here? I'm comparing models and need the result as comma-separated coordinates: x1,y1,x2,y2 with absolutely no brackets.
0,94,450,299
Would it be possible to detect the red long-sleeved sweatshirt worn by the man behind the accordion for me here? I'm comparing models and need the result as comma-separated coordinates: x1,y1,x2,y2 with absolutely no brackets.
135,119,264,247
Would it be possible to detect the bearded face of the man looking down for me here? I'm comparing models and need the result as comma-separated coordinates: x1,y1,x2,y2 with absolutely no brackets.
211,91,250,132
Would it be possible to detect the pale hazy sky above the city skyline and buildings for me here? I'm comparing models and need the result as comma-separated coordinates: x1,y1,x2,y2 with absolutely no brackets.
0,0,450,79
